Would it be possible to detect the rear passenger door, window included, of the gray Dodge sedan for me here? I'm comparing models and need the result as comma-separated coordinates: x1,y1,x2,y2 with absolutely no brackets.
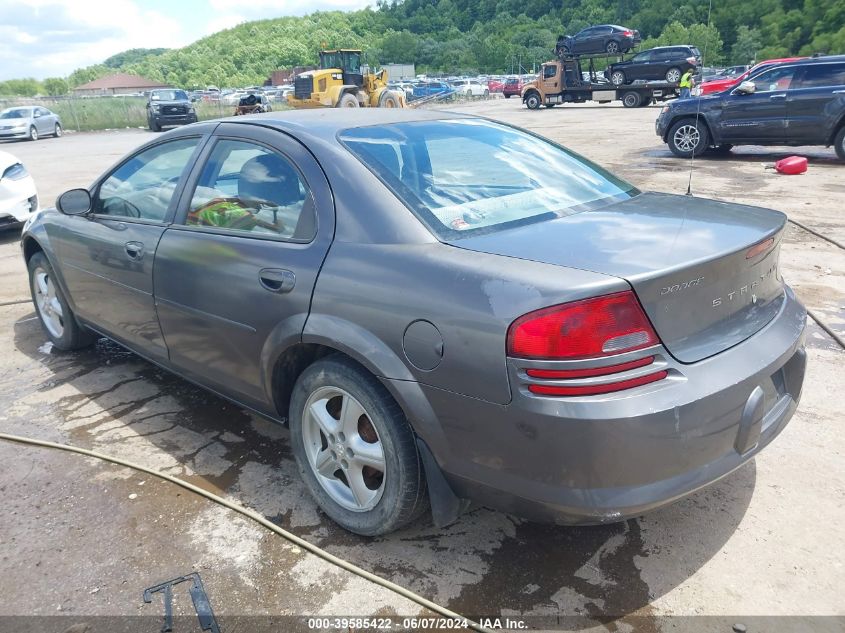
155,124,334,414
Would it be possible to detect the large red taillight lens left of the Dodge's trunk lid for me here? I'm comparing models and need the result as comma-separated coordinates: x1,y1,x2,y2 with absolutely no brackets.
507,290,660,360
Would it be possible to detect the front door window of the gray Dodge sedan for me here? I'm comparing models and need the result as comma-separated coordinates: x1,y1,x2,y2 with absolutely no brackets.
92,137,200,222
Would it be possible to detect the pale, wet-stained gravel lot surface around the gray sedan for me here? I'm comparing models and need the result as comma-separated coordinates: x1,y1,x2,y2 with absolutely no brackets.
0,99,845,632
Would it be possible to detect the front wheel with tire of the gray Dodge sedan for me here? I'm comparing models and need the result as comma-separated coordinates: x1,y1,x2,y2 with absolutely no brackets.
27,253,96,351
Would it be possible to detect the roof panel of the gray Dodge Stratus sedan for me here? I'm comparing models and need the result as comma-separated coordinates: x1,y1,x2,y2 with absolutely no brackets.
227,108,478,141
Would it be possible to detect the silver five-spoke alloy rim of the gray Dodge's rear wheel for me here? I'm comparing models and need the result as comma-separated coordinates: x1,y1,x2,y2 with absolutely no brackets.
302,386,387,512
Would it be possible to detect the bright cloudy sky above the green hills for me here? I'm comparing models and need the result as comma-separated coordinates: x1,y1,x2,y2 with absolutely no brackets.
0,0,375,81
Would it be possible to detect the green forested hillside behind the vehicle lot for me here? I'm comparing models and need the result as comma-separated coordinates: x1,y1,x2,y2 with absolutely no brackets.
0,0,845,93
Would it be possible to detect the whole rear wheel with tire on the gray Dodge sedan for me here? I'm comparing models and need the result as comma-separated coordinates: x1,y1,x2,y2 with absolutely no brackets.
290,354,428,536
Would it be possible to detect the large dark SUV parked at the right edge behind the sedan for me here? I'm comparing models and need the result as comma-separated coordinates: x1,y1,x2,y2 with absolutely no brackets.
656,55,845,160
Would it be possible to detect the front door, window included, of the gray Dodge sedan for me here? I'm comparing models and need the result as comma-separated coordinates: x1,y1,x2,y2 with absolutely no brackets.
51,136,202,359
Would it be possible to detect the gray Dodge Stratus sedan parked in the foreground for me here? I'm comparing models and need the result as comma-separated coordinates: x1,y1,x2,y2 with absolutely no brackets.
22,109,806,535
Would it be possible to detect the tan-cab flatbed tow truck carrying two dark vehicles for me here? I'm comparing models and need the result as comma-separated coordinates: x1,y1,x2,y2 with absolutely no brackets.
522,55,679,110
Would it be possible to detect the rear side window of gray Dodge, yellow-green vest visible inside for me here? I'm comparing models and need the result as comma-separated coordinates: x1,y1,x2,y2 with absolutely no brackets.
185,139,317,241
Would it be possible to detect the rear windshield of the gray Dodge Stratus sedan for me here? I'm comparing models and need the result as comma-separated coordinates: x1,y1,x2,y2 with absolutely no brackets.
340,119,639,239
